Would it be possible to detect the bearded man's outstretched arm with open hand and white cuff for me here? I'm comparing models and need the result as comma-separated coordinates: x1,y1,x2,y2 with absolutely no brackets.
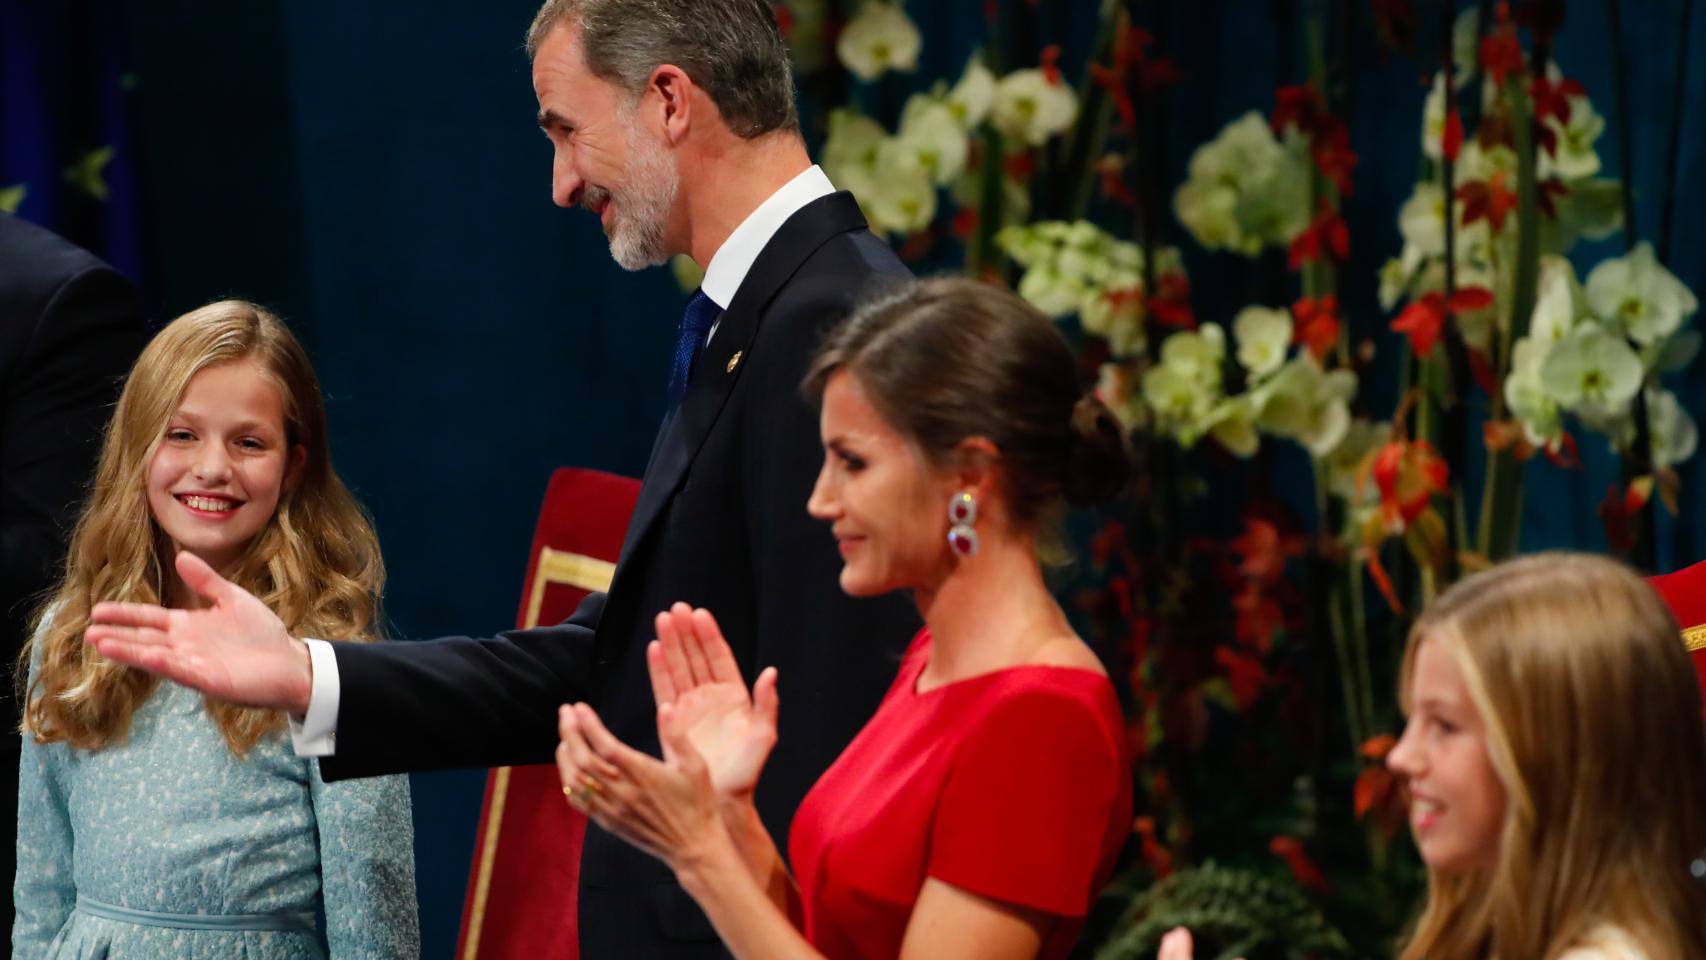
85,554,604,779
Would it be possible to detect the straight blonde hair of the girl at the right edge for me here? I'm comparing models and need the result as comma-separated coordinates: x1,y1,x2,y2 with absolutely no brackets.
1401,552,1706,960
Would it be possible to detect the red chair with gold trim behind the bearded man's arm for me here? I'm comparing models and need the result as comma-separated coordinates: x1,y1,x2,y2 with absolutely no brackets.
456,467,640,960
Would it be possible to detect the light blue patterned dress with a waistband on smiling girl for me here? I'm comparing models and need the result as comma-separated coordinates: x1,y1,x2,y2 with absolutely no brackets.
12,654,420,960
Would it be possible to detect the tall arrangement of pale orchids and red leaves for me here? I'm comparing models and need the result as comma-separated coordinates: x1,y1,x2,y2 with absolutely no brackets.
764,0,1701,957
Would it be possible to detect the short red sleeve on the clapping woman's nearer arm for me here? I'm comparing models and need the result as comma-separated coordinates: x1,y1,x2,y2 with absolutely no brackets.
926,670,1131,917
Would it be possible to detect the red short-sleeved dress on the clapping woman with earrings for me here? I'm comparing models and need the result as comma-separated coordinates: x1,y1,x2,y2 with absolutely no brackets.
790,629,1131,960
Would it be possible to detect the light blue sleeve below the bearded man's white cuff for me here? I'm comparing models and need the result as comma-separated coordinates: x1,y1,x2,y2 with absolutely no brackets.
309,760,421,960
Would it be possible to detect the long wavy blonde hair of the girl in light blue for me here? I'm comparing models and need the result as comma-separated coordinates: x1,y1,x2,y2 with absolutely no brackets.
19,300,386,755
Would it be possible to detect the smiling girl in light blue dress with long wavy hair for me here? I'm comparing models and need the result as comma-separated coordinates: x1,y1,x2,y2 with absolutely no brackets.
12,300,420,960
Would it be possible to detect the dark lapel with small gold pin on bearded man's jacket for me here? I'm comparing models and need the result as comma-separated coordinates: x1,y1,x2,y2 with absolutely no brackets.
611,191,865,576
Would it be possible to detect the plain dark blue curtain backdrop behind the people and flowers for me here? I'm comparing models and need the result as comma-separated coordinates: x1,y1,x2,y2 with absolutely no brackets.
13,0,1706,957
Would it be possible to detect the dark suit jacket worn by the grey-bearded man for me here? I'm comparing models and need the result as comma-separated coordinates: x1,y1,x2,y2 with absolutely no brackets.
321,193,918,958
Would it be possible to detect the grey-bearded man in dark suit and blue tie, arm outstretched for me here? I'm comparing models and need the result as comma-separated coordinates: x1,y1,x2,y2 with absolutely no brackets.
89,0,918,957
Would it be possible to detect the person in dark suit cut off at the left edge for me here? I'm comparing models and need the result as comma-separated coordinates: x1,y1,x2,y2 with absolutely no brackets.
0,213,142,948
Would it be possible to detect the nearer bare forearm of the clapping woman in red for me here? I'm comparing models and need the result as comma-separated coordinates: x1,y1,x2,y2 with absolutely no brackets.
674,815,822,960
